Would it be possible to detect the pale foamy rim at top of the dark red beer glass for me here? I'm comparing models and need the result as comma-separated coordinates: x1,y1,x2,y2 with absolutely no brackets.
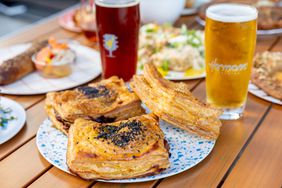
95,0,140,8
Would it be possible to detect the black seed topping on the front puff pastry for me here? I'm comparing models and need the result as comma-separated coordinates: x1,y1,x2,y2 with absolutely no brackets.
96,120,146,147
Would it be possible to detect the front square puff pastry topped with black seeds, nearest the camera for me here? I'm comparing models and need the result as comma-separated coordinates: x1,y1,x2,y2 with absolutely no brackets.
67,114,170,180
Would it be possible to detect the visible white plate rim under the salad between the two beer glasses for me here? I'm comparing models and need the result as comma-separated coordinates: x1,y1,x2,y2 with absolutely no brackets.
137,69,206,81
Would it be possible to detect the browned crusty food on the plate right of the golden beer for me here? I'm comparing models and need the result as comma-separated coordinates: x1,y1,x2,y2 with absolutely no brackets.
251,52,282,100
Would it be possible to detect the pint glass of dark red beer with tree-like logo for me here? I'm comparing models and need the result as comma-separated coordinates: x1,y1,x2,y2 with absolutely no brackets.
95,0,140,81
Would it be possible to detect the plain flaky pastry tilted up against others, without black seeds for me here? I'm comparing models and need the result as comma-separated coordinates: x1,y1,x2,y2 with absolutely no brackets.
131,63,222,139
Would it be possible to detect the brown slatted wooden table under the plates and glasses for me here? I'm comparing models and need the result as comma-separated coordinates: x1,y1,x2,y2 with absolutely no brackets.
0,7,282,188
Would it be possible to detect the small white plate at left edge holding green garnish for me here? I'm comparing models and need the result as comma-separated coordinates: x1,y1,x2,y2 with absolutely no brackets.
0,97,26,144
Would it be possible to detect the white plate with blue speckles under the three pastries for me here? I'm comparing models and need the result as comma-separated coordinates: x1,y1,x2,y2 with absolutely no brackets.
36,119,215,183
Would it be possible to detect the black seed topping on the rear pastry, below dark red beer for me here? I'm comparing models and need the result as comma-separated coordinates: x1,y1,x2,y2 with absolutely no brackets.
77,86,110,98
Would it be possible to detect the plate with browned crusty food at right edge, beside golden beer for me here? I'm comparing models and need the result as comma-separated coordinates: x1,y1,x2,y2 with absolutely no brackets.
249,51,282,105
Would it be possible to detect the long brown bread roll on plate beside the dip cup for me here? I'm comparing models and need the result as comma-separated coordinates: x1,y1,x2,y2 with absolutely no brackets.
0,41,47,85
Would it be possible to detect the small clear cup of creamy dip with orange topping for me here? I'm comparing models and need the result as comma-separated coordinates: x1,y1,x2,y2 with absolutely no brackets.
32,38,75,78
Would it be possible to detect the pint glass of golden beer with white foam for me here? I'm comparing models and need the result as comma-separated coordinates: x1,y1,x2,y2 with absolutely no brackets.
205,4,258,120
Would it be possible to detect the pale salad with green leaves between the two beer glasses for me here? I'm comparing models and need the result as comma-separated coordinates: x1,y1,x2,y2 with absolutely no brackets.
138,24,205,75
